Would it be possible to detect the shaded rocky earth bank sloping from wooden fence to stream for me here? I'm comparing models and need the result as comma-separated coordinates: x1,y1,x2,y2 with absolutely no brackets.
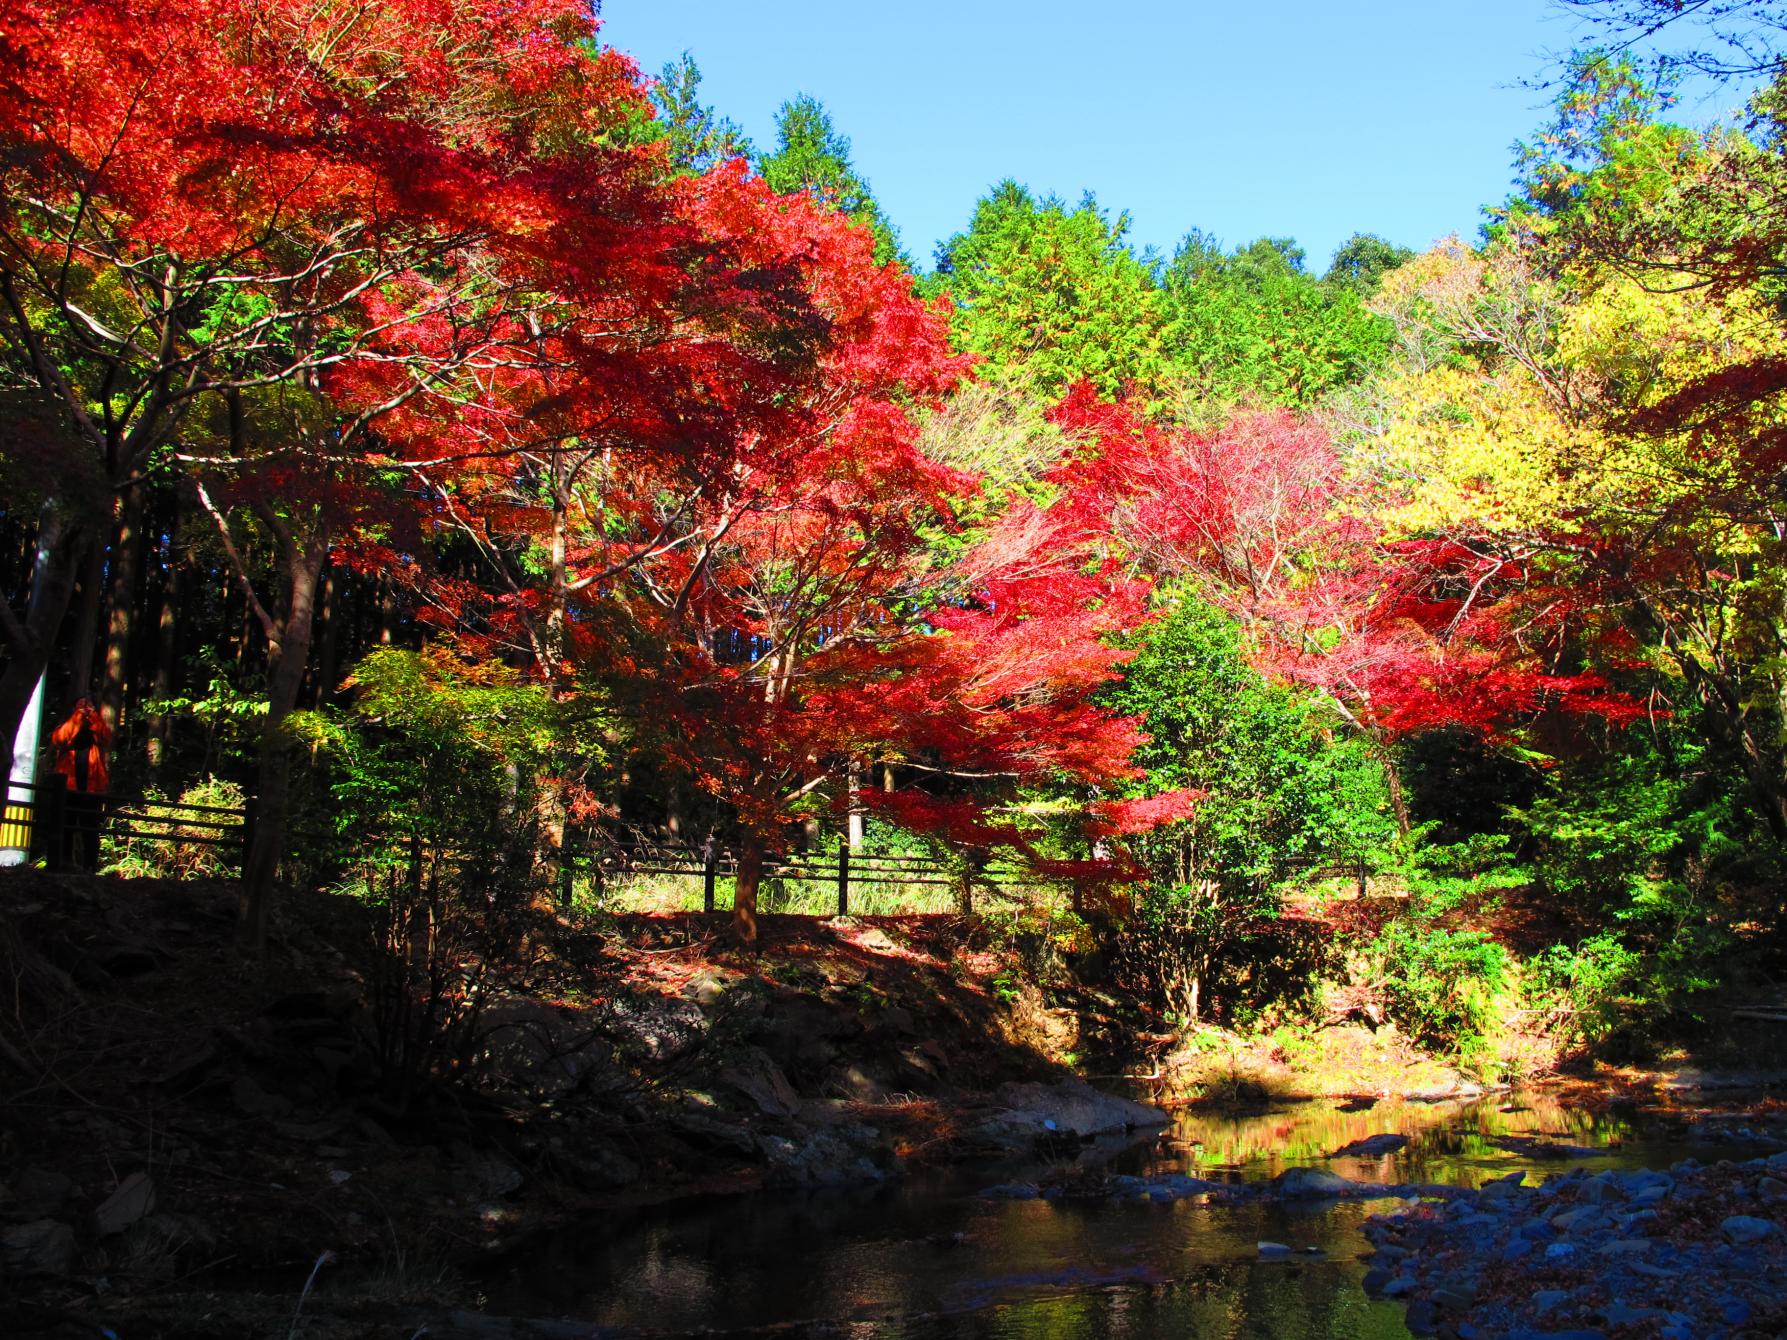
0,872,1779,1340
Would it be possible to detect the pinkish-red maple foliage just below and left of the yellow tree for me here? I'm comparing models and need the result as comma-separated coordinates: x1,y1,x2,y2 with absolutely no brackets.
1056,388,1639,764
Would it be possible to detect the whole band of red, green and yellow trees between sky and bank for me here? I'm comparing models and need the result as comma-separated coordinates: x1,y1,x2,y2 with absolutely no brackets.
0,0,1787,1077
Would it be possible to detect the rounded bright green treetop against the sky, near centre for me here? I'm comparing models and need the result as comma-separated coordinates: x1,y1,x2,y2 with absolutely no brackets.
931,180,1165,397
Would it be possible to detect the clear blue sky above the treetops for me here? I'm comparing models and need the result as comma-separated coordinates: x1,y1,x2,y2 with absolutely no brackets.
602,0,1735,272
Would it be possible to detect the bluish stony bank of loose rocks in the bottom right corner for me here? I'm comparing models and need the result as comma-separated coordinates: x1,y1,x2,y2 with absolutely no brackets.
1365,1154,1787,1340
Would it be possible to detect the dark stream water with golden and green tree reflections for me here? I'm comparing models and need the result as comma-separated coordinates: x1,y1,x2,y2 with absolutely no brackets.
488,1095,1715,1340
